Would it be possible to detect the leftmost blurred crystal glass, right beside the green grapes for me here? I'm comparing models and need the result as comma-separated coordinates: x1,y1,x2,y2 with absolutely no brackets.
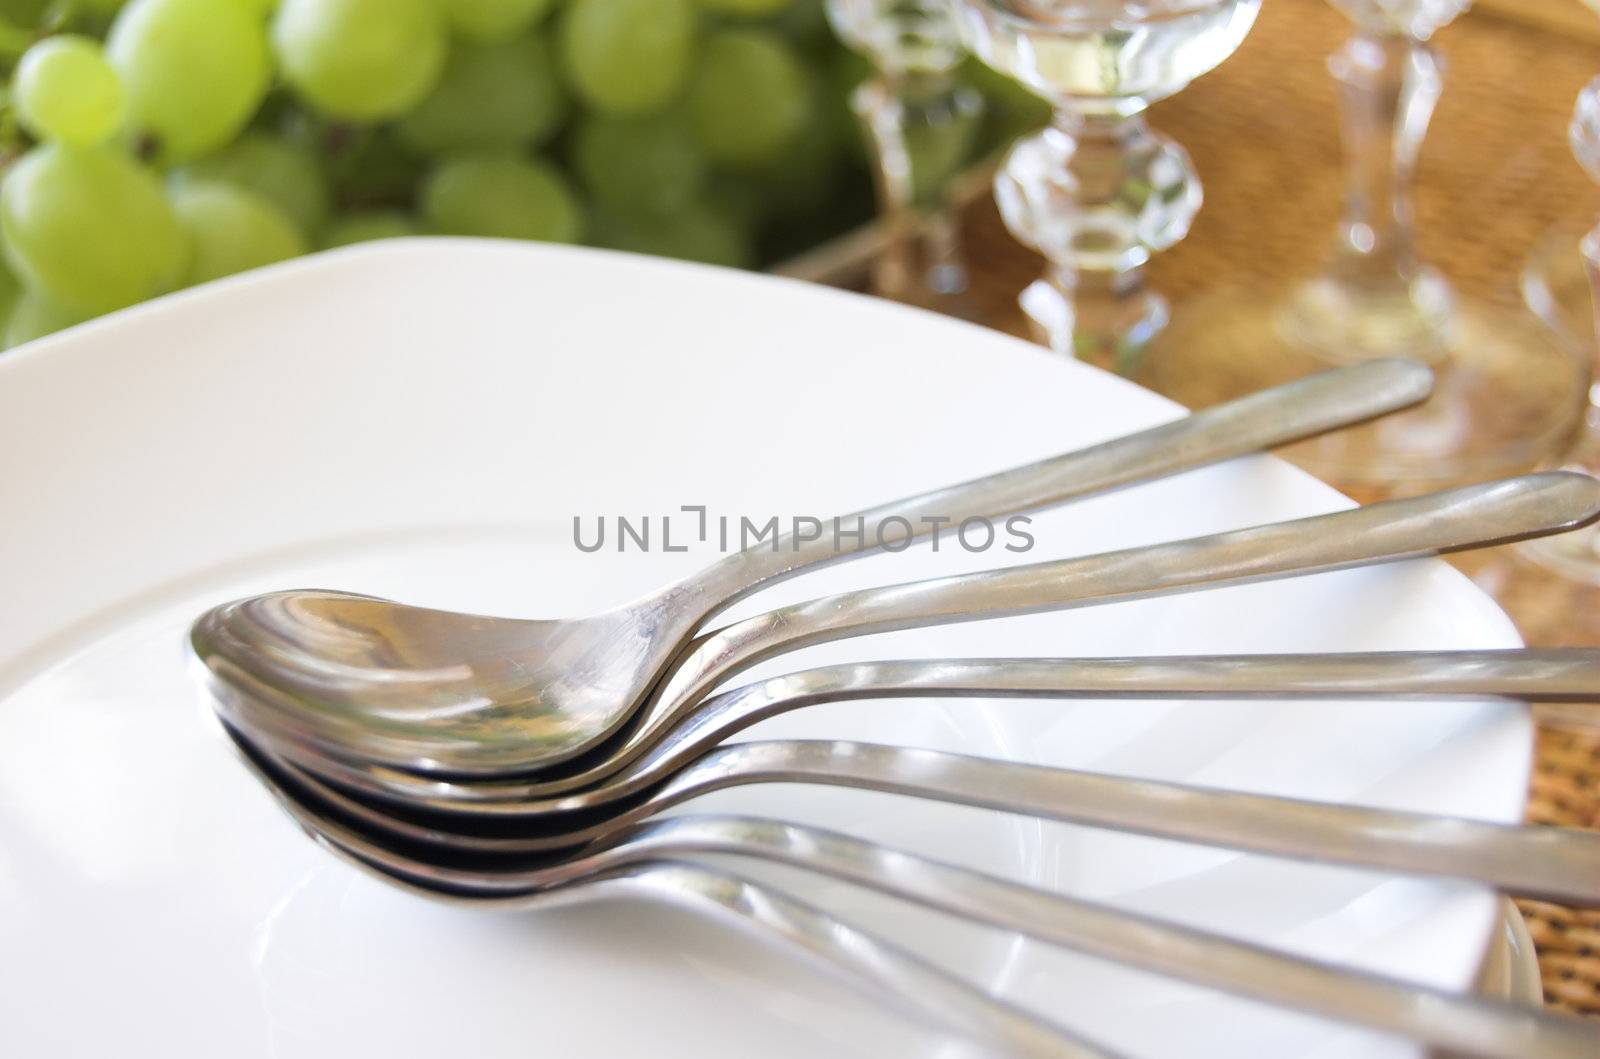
826,0,984,315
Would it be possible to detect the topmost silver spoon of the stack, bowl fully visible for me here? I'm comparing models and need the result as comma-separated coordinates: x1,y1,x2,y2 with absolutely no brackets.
192,360,1432,774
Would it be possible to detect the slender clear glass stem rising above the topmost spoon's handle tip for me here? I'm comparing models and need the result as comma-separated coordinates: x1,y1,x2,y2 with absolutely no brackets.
1294,30,1451,360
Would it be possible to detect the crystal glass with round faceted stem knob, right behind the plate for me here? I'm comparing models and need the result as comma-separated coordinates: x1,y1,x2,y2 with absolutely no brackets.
955,0,1261,373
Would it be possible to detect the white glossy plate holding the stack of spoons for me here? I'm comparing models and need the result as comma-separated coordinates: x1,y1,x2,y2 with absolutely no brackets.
0,240,1530,1059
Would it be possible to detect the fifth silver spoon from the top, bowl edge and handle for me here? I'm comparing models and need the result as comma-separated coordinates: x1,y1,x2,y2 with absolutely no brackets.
235,734,1594,1059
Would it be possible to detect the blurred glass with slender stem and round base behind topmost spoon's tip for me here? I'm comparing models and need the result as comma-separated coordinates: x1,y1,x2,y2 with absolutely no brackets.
1141,0,1587,491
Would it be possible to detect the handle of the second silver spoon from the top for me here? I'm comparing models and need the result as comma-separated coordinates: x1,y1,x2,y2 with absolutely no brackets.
643,472,1600,713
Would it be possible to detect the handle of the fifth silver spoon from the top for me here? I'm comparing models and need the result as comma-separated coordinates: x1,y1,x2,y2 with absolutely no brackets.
608,816,1595,1059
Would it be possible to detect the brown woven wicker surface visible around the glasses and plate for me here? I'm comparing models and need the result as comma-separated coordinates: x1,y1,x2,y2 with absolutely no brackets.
921,0,1600,1017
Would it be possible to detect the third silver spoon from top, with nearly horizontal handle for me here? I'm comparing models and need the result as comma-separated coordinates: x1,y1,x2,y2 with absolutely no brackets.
224,648,1600,814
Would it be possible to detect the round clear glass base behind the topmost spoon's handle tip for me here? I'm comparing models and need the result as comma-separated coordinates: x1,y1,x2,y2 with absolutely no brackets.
1102,288,1589,496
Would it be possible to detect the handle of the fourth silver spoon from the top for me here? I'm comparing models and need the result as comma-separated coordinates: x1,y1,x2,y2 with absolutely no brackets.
681,741,1600,907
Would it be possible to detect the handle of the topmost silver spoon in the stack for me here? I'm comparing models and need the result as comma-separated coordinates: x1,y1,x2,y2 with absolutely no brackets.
694,357,1434,609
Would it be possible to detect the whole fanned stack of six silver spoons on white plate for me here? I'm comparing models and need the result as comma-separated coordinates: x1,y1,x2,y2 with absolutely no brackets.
192,360,1600,1057
